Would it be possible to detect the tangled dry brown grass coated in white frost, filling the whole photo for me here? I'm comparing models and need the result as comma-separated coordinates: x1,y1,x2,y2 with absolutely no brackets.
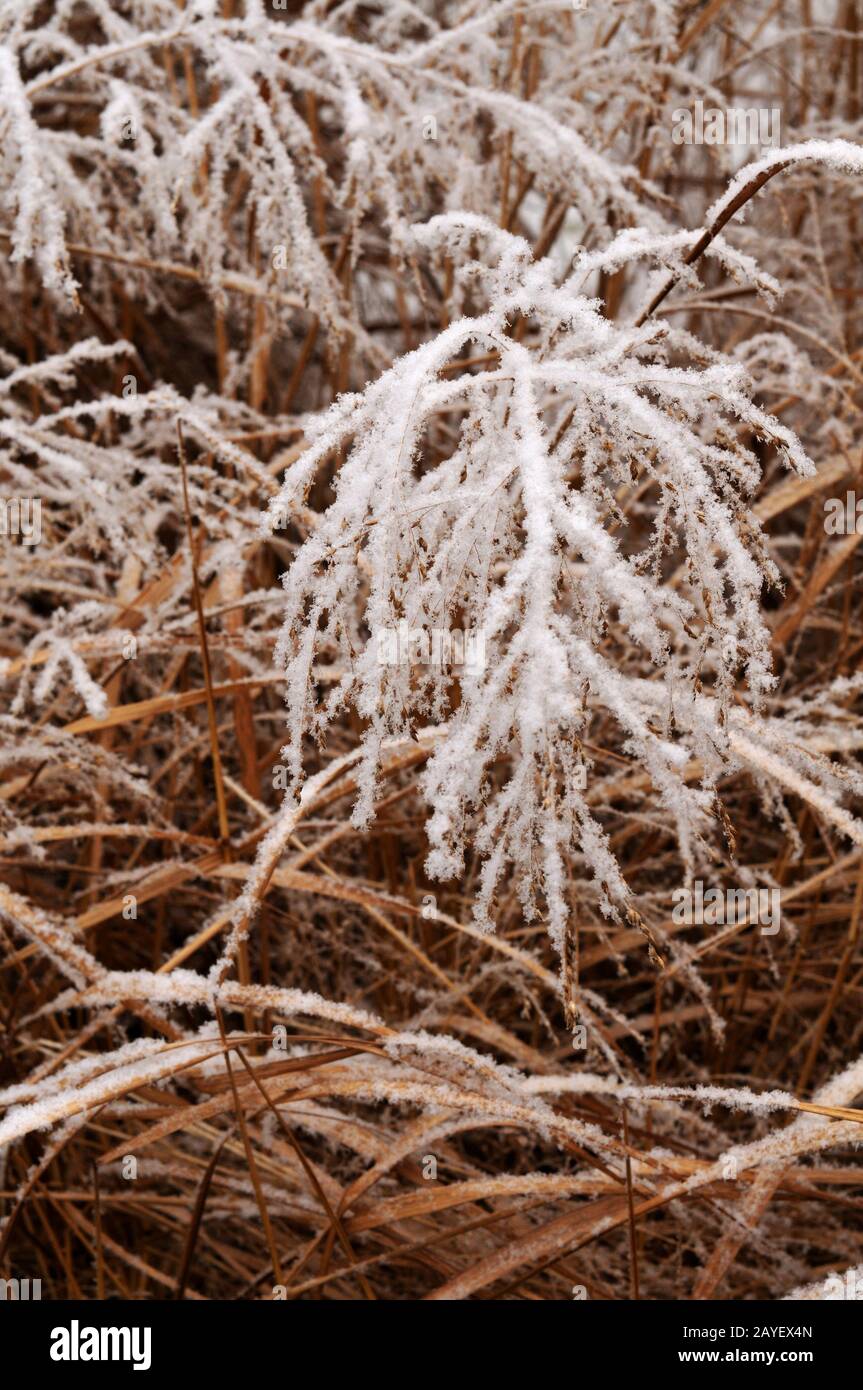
0,0,863,1300
